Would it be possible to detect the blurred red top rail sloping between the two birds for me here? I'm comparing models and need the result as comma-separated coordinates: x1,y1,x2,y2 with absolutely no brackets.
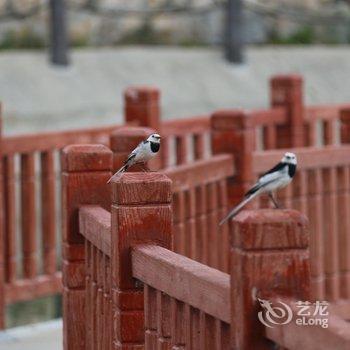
165,154,234,192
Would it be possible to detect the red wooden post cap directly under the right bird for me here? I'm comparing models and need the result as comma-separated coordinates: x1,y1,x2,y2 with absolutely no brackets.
232,209,309,250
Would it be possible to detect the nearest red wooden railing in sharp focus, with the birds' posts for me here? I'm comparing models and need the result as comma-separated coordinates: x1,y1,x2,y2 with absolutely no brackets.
63,146,309,350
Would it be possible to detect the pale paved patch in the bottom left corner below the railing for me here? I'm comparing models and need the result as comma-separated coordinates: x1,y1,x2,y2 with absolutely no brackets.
0,320,63,350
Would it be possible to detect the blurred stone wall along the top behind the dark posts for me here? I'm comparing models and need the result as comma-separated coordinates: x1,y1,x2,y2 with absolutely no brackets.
0,0,350,48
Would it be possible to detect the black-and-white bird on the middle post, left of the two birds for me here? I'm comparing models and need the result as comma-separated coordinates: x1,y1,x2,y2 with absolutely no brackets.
107,134,161,183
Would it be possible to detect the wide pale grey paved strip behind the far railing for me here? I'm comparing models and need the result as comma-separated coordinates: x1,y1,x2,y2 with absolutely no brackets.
0,46,350,133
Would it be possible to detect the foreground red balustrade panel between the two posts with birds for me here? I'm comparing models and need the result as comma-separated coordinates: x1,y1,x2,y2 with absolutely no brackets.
132,245,230,350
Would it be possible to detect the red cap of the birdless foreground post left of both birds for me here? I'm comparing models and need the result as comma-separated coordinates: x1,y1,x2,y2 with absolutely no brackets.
61,144,113,171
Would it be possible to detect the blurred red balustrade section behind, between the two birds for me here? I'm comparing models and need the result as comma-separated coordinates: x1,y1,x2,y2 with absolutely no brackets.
165,154,234,272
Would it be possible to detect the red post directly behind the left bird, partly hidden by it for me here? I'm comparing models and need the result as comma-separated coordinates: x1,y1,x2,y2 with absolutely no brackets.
109,126,154,171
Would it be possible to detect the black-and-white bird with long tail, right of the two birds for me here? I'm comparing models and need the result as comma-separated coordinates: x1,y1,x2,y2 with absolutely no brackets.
220,152,297,225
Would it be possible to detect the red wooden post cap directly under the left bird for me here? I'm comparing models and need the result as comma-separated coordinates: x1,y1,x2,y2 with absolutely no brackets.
111,173,172,205
